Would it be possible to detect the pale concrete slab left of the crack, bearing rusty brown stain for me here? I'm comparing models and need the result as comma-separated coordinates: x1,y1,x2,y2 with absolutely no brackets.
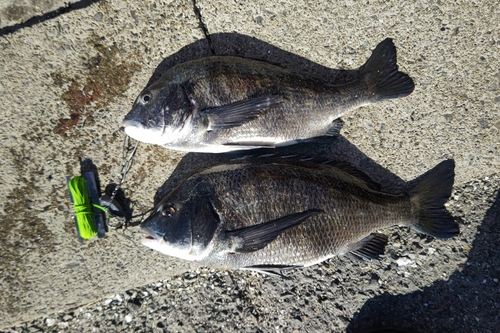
0,1,204,326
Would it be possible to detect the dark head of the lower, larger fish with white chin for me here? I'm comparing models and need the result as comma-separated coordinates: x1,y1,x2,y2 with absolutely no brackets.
141,185,220,261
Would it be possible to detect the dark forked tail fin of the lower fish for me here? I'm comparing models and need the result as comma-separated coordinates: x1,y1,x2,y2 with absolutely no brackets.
410,160,460,238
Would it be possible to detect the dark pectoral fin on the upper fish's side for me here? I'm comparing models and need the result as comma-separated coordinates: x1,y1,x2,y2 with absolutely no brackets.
201,95,283,130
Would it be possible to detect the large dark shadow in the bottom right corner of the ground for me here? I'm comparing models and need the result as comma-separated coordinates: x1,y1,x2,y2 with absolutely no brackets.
347,191,500,333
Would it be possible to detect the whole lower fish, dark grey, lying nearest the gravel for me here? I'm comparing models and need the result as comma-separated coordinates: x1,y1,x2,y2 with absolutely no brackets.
141,159,459,273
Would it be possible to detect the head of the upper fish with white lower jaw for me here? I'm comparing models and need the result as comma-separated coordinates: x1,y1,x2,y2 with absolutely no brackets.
122,82,193,145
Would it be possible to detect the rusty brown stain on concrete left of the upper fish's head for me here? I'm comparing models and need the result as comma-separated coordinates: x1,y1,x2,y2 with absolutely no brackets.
51,35,140,139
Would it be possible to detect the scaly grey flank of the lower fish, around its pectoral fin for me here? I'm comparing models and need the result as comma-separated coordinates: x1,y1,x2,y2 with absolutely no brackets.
194,165,408,267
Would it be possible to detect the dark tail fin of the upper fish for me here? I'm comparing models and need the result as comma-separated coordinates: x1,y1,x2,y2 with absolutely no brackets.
359,38,415,102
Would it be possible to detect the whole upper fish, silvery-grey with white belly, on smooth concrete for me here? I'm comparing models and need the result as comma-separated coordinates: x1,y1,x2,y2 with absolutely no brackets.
123,39,414,153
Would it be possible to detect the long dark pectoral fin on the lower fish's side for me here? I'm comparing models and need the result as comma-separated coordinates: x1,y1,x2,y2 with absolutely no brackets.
226,209,323,252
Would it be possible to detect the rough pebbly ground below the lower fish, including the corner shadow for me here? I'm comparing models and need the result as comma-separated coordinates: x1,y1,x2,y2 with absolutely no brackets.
3,156,500,332
